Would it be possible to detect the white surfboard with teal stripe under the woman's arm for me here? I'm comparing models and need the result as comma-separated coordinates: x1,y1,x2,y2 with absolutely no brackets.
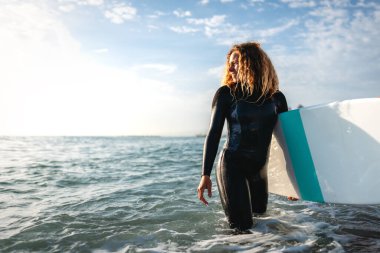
268,98,380,204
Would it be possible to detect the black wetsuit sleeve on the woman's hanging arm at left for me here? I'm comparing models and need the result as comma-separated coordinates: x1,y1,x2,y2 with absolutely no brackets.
202,86,230,176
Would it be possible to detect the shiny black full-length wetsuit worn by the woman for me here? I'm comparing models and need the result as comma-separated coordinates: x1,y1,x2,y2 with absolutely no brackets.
202,86,288,230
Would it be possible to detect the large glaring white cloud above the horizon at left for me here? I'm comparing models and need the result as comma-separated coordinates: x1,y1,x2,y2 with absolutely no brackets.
0,2,209,135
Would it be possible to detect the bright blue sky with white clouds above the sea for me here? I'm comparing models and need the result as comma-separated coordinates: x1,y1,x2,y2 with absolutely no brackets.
0,0,380,136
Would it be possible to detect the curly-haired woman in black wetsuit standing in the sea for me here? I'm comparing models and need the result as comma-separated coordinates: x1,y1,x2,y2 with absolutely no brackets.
198,42,288,231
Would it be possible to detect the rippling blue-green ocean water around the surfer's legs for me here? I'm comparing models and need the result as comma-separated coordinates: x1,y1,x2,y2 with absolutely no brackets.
0,137,380,252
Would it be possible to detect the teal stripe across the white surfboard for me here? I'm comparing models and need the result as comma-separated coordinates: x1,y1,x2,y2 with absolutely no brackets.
279,109,324,202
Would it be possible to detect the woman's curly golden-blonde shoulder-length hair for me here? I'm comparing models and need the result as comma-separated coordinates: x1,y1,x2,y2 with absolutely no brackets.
222,42,279,99
